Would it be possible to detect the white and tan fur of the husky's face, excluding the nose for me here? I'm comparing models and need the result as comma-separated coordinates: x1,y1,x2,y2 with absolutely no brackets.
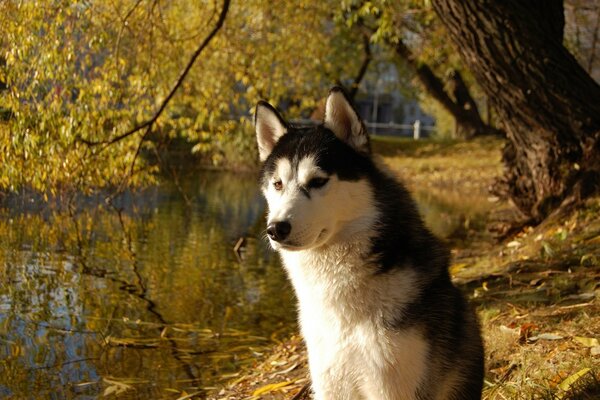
263,156,376,250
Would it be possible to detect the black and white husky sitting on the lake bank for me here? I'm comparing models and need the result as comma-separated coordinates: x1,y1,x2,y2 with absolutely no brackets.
255,88,483,400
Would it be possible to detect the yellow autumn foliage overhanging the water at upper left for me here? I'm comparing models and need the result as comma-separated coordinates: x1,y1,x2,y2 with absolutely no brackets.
0,0,368,193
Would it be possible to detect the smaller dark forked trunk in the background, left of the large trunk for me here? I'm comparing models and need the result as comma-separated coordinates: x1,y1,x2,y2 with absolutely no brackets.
393,40,501,139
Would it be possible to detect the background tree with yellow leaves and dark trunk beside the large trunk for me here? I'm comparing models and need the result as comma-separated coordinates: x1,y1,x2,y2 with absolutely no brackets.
341,0,502,138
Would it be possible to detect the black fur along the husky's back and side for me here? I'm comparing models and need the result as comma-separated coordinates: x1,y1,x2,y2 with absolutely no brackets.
358,166,484,400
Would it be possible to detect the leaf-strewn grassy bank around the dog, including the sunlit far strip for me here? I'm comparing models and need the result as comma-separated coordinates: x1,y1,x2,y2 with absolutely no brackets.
209,139,600,400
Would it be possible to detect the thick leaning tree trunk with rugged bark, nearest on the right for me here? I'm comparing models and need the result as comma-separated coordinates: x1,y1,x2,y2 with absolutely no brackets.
432,0,600,221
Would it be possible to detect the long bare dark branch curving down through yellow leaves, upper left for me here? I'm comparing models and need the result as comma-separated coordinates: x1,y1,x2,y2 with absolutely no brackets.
79,0,230,146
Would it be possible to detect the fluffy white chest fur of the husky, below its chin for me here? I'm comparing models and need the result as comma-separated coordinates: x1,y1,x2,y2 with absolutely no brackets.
284,251,428,399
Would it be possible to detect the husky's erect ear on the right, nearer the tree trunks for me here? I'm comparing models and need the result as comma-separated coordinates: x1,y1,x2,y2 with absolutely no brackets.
323,87,371,154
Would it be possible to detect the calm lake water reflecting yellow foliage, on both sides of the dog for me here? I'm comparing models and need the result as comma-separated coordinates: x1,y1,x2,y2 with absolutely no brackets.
0,172,492,399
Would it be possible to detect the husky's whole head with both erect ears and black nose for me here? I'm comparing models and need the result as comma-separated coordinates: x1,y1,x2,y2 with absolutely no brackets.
255,88,376,250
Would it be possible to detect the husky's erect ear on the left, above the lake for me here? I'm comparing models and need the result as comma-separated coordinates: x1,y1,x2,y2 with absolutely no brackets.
254,100,287,161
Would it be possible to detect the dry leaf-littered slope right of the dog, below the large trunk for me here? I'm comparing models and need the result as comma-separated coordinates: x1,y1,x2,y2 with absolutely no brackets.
468,199,600,399
